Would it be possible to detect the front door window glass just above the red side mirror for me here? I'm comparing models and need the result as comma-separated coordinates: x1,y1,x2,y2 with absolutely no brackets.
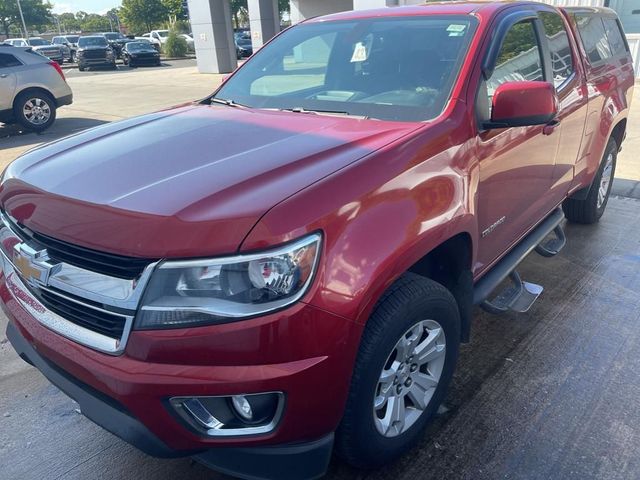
487,20,544,98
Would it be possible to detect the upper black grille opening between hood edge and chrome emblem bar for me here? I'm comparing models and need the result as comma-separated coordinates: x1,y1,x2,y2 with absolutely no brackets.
8,219,157,280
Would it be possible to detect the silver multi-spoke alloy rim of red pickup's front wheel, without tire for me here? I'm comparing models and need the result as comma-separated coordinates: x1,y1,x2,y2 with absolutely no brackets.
373,320,446,437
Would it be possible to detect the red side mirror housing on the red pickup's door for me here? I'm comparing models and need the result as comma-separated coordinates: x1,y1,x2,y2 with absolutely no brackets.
484,81,558,129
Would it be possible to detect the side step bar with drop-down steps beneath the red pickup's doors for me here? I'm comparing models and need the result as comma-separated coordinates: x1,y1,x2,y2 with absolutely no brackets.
473,208,565,313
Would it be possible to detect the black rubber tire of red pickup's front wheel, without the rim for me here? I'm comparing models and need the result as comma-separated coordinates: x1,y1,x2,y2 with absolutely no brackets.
336,273,460,469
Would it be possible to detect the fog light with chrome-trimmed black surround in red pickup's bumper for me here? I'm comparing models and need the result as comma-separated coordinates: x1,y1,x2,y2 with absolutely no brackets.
169,392,284,436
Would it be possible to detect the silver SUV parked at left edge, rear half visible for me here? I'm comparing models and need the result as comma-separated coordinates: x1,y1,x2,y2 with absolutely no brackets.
0,45,73,132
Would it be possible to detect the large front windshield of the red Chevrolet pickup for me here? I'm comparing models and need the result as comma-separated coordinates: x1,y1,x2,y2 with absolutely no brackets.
215,15,476,121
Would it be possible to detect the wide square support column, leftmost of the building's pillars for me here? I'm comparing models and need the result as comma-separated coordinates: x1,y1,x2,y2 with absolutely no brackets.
188,0,238,73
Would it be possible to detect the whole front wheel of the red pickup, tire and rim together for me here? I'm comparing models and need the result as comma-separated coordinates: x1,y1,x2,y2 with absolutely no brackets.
336,273,460,468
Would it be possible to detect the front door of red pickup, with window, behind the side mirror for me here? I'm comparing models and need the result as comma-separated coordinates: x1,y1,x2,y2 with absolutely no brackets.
475,9,560,274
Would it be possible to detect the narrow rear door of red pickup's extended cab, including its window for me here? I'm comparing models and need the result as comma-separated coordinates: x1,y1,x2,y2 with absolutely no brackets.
538,10,588,203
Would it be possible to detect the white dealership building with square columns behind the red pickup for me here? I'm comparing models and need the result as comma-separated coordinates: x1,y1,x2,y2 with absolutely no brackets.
188,0,640,77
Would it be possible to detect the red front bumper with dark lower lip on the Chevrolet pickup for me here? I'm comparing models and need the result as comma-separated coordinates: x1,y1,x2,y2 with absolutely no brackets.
0,262,362,478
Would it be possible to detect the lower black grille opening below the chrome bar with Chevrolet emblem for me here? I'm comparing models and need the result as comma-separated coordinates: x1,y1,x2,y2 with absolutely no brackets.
37,288,126,339
